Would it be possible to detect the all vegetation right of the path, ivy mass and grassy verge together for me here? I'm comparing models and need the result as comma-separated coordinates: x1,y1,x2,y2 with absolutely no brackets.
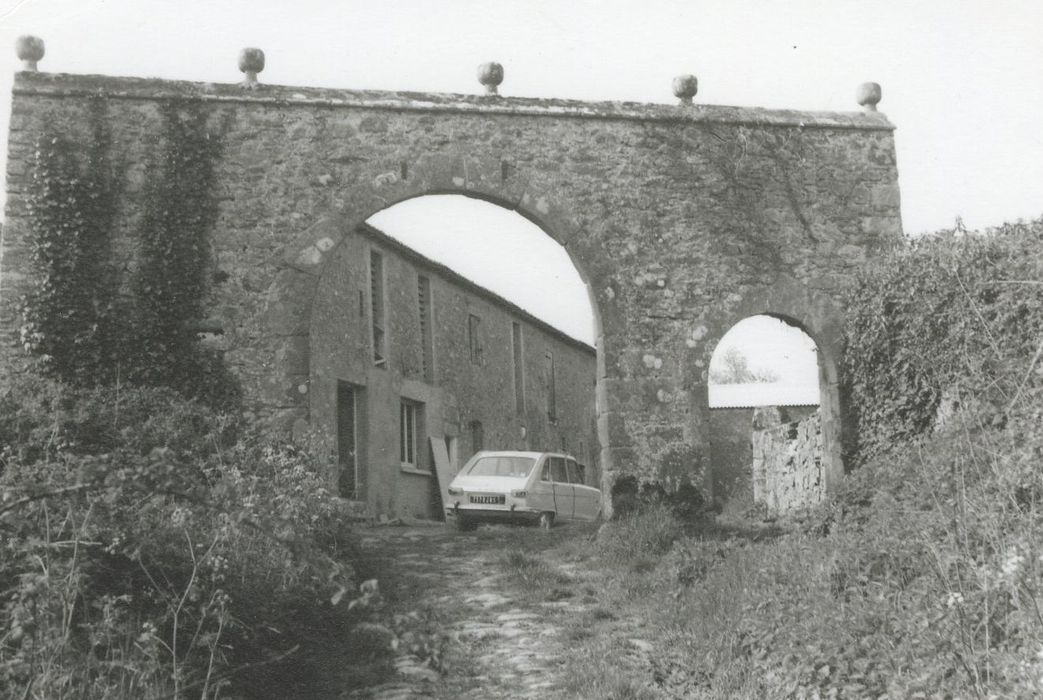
488,215,1043,700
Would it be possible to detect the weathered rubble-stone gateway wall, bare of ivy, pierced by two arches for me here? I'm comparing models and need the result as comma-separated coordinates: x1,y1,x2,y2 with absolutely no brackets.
0,72,900,511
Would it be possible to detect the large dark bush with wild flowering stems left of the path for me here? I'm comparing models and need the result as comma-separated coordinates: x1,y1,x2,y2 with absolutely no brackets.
0,380,379,698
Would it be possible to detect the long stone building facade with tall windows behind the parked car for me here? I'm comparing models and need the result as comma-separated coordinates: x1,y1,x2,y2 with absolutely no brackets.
311,225,599,517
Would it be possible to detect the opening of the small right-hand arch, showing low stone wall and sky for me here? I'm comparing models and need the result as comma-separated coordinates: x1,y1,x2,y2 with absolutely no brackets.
708,314,831,515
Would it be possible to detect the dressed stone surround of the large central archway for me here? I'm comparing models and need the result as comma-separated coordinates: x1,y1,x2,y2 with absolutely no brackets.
259,148,611,484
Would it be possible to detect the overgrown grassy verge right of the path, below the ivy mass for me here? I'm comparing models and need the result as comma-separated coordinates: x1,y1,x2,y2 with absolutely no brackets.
492,404,1043,700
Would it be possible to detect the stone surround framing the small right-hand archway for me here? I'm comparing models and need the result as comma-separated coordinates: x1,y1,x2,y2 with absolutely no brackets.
689,275,845,500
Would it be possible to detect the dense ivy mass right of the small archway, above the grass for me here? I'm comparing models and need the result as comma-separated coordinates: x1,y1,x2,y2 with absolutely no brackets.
843,219,1043,463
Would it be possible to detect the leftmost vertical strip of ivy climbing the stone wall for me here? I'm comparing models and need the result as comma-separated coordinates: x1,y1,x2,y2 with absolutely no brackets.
21,99,121,385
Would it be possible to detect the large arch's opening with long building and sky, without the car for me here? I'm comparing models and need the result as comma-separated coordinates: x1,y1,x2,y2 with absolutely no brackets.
310,194,600,517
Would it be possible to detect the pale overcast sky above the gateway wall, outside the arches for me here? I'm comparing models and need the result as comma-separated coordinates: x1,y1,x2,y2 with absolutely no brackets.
0,0,1043,385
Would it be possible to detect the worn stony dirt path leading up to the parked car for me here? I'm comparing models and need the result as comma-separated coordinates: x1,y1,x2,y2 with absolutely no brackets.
348,525,640,700
